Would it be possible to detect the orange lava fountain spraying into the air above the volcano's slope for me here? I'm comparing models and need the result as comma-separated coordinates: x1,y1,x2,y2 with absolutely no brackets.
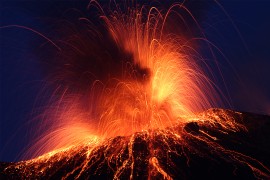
25,1,220,156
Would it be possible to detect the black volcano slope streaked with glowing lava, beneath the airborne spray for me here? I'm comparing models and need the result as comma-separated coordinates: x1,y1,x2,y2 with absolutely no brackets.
0,109,270,179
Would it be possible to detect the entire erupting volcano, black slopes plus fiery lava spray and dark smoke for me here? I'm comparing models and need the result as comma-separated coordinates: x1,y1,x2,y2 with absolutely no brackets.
0,0,270,179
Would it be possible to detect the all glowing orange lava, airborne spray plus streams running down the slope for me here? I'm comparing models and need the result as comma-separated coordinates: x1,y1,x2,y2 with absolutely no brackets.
1,1,269,179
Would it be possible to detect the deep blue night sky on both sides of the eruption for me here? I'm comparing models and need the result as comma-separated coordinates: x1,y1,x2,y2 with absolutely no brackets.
0,0,270,161
